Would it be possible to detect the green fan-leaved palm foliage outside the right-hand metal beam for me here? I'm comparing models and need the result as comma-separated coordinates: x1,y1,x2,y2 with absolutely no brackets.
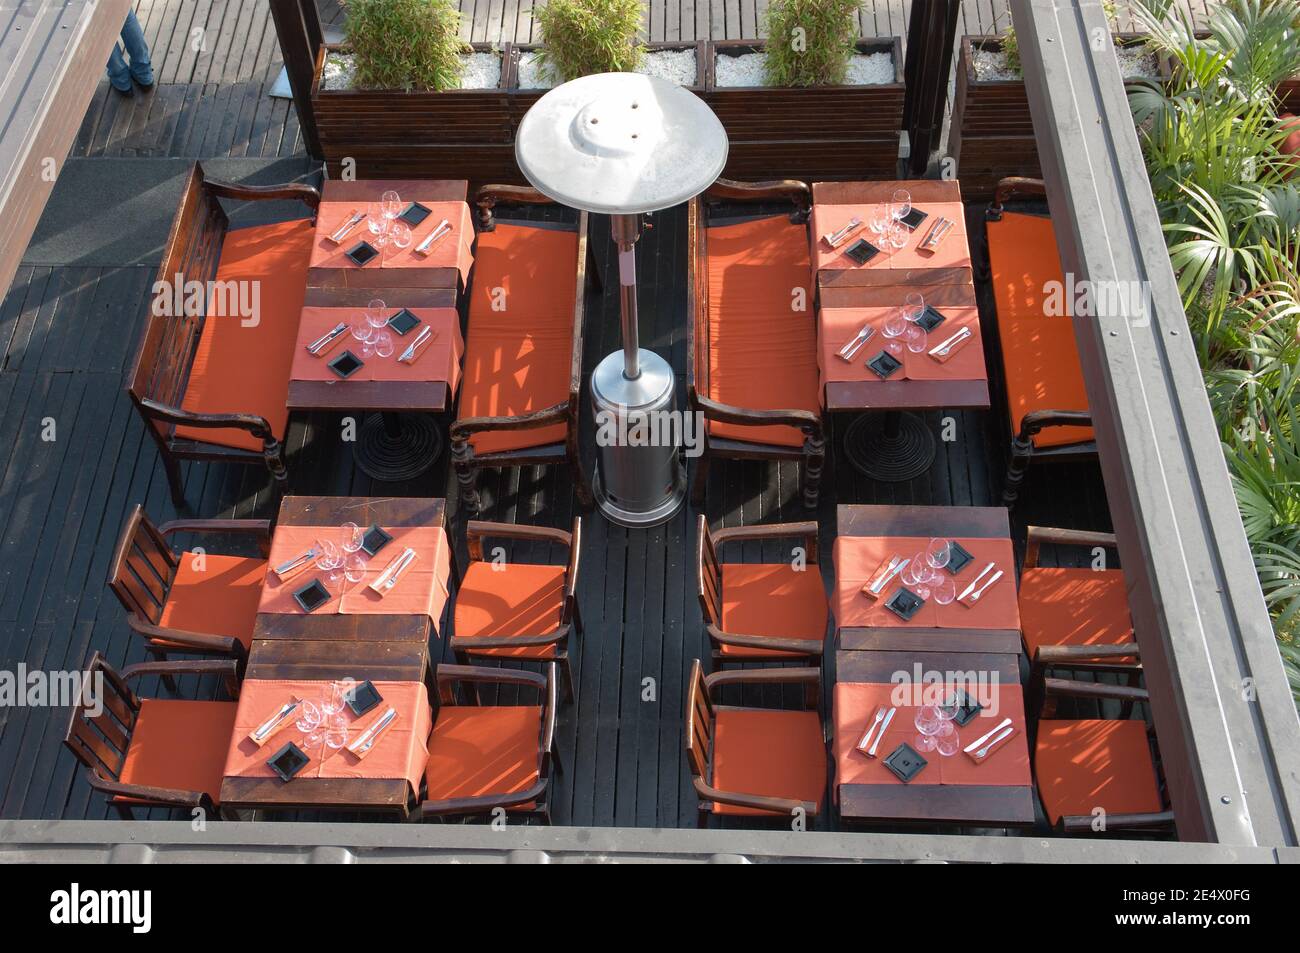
1128,0,1300,701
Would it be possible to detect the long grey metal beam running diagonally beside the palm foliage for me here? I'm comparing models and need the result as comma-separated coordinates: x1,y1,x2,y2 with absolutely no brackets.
1011,0,1300,845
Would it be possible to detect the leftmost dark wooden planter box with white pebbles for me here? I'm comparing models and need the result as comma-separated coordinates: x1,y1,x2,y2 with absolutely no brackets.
312,43,519,182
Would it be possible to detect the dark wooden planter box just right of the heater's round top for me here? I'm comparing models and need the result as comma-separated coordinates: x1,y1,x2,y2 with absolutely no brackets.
703,36,905,179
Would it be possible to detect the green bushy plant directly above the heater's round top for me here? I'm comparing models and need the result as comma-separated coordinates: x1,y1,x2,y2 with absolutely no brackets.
533,0,645,82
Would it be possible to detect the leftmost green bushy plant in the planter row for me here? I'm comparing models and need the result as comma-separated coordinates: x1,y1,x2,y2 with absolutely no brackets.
346,0,468,90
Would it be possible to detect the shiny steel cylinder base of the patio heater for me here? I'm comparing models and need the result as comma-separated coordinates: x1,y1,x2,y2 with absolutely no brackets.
592,348,686,528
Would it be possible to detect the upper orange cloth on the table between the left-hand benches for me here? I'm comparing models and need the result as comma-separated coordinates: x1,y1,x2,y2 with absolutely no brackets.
309,195,475,285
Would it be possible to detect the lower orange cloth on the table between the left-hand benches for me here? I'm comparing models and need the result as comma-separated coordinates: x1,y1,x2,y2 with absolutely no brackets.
289,307,465,394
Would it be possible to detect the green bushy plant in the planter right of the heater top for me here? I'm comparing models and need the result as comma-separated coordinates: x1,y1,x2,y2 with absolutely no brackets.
763,0,861,86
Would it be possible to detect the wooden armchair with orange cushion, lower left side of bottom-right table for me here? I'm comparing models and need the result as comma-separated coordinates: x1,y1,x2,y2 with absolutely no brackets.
685,659,827,827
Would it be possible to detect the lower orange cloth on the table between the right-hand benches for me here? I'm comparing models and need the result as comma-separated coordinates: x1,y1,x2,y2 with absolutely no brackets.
818,302,988,384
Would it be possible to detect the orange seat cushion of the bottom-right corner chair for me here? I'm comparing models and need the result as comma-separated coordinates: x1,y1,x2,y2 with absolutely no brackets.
1034,719,1162,824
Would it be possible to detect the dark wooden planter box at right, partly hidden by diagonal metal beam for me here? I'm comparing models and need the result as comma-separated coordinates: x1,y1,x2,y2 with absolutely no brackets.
948,34,1167,200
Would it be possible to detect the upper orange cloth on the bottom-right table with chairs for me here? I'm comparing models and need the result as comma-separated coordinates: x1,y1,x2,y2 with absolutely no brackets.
831,536,1021,629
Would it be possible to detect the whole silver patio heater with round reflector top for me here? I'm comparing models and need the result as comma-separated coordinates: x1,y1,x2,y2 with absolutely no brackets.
515,73,727,528
